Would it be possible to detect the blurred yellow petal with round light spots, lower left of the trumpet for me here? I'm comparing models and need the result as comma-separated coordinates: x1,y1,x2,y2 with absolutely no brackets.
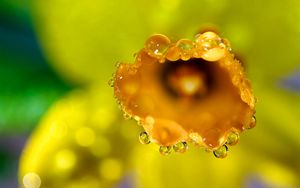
19,85,138,188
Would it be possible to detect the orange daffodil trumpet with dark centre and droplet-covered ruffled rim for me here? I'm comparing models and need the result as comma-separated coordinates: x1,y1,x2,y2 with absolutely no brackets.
114,32,255,156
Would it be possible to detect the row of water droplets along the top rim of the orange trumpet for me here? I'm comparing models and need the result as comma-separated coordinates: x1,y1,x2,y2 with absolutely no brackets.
145,32,231,63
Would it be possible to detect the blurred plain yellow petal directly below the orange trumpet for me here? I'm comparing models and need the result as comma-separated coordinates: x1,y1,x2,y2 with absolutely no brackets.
134,146,300,188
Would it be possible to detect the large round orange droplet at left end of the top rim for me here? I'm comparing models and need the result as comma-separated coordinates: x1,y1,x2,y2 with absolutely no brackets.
145,34,171,59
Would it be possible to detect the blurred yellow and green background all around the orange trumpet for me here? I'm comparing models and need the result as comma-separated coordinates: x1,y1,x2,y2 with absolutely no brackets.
0,0,300,188
